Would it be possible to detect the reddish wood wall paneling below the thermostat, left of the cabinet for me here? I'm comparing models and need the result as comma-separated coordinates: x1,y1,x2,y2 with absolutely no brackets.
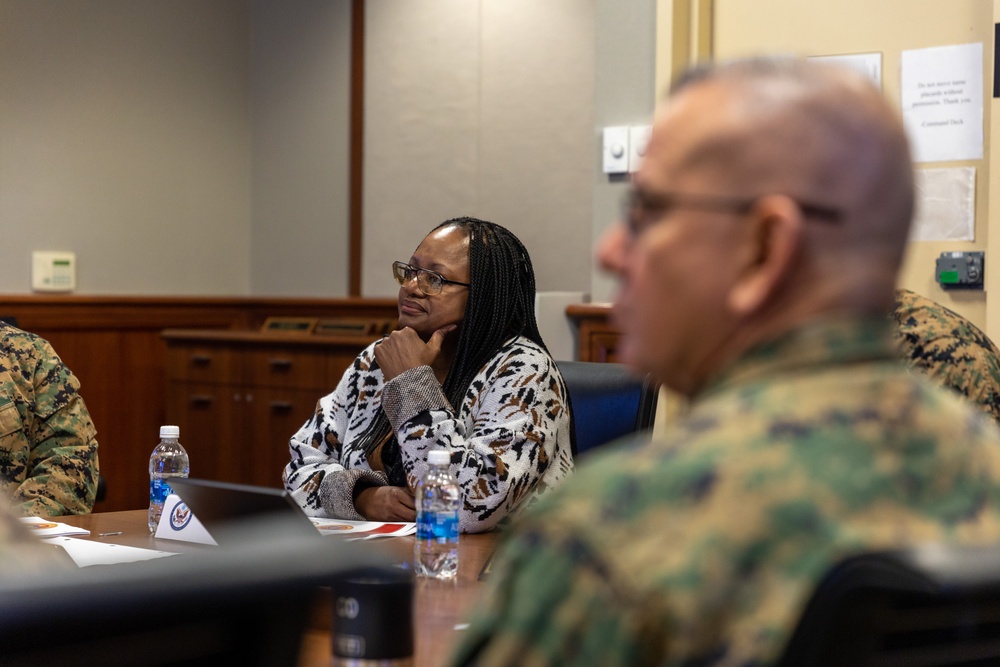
10,297,247,511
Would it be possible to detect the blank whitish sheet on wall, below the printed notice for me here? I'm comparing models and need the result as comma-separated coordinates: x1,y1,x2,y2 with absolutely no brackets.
910,167,976,241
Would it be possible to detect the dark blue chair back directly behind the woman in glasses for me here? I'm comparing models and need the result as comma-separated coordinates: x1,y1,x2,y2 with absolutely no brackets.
556,361,658,457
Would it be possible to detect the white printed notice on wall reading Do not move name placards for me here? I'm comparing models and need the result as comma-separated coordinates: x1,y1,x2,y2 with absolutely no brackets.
900,42,983,162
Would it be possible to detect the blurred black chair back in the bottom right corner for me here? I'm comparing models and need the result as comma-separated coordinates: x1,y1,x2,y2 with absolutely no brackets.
778,545,1000,667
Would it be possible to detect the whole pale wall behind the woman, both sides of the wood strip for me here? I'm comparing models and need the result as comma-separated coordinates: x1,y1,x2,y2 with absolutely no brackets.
0,0,654,296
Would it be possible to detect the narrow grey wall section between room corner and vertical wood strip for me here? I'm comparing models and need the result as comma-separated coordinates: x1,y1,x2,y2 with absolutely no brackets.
249,0,351,297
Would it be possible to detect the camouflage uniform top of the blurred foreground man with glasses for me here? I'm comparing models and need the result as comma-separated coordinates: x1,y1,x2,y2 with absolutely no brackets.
454,319,1000,667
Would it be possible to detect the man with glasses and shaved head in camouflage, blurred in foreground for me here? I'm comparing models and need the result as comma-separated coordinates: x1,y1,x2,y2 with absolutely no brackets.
454,60,1000,667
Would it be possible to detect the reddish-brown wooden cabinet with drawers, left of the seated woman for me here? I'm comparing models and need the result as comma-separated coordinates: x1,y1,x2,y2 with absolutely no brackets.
163,329,376,487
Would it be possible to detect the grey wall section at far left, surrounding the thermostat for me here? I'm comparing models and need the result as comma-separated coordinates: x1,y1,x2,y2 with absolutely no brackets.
0,0,250,294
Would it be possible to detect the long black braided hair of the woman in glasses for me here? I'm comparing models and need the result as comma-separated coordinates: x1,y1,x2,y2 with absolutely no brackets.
359,217,546,486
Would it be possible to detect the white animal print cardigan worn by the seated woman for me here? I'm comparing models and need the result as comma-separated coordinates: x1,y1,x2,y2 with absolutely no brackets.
284,337,573,533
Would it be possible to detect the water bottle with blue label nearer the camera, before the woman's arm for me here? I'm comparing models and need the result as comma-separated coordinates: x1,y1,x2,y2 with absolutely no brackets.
413,449,462,579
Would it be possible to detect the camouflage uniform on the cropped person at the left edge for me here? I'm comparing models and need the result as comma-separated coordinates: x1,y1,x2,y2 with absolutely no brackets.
0,323,98,515
